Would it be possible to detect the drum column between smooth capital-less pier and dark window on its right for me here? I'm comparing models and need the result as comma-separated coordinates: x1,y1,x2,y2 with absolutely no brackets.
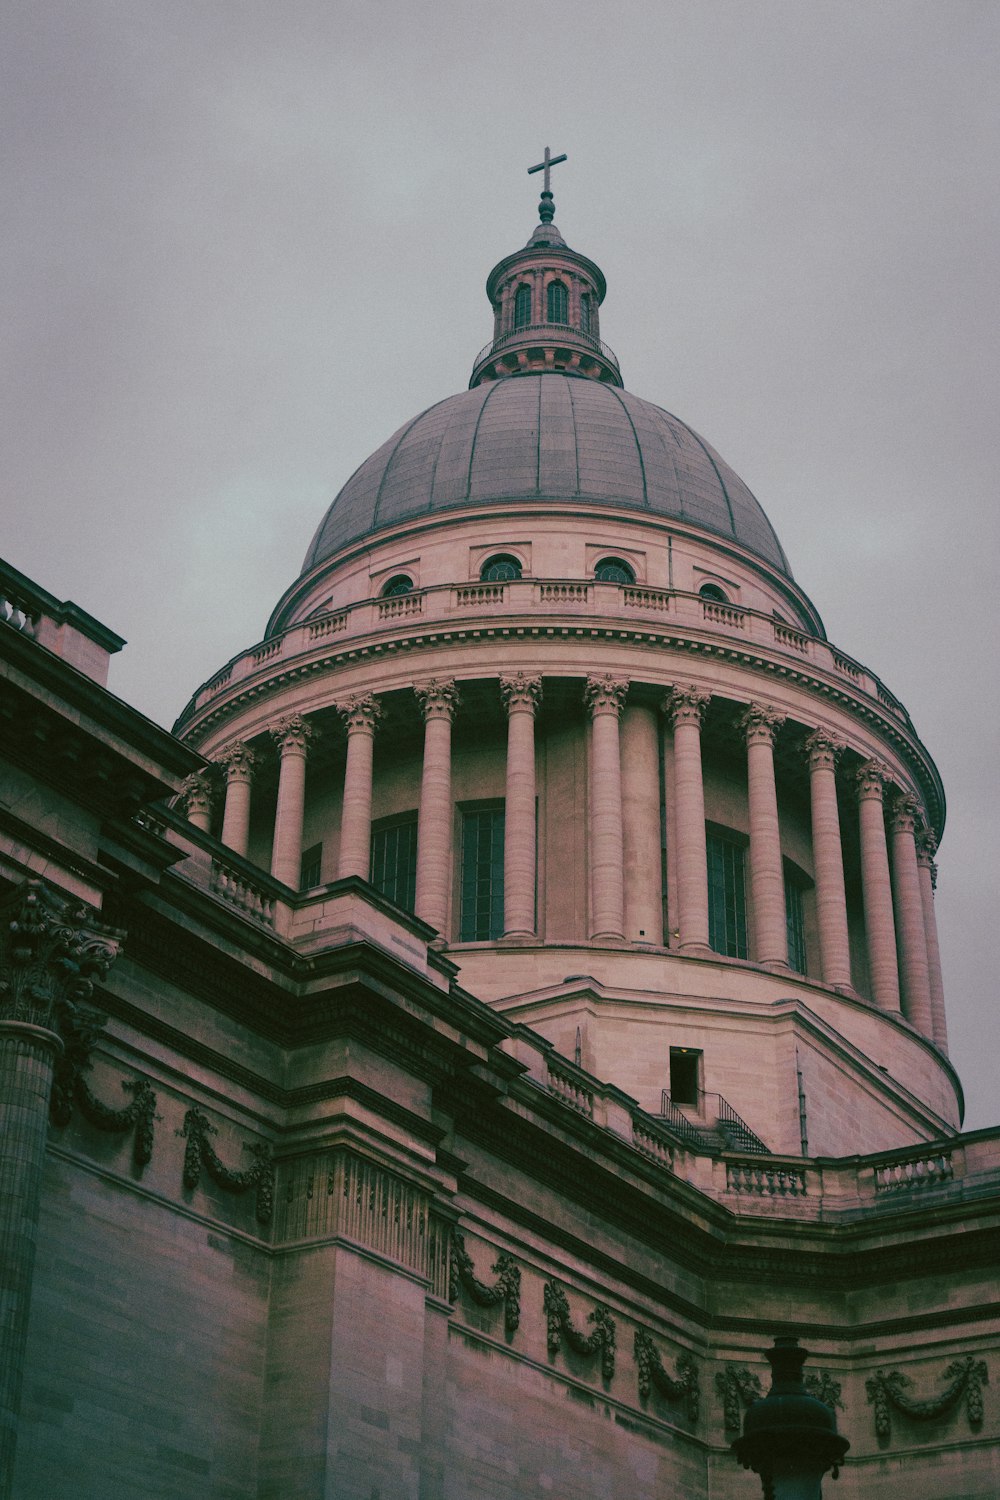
663,686,711,953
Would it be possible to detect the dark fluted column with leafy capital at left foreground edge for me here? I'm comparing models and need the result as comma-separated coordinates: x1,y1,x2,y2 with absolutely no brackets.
0,881,121,1500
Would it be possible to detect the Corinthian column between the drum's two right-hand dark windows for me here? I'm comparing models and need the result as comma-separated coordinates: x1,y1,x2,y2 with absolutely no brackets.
739,704,789,969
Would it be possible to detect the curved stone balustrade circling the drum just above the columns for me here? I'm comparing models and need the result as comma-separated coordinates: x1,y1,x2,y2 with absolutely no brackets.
178,579,912,729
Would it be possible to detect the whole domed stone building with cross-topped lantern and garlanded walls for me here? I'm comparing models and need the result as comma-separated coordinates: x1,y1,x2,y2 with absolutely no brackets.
0,178,1000,1500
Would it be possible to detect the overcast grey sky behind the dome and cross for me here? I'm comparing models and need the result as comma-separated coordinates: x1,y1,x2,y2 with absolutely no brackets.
0,0,1000,1128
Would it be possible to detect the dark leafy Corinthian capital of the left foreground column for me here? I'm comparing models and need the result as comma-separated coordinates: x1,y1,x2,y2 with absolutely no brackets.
0,881,124,1031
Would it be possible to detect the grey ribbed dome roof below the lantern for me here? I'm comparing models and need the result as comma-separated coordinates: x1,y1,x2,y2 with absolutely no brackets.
303,371,792,578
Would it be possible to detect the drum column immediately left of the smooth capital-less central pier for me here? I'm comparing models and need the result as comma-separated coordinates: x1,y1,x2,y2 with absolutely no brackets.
583,672,628,941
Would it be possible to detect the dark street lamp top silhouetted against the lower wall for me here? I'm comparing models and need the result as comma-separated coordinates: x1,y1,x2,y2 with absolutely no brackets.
733,1338,850,1500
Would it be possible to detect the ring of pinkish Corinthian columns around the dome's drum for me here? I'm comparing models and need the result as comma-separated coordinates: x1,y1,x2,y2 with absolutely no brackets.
186,672,946,1047
